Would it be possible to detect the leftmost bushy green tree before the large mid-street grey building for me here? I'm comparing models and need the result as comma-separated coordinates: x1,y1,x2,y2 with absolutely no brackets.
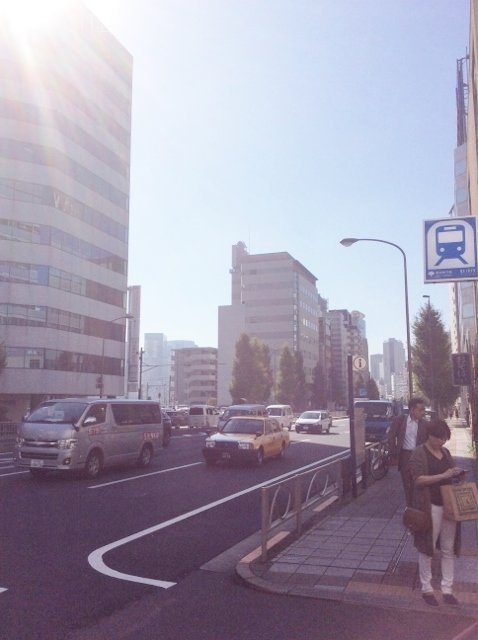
229,333,272,403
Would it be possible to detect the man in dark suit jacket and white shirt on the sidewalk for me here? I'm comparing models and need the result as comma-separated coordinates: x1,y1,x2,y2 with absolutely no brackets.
388,398,428,507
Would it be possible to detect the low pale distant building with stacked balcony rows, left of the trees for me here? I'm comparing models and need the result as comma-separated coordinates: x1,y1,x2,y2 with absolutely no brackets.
172,347,217,406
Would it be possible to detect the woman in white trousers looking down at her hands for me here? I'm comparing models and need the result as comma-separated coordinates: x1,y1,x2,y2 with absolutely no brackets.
410,420,462,607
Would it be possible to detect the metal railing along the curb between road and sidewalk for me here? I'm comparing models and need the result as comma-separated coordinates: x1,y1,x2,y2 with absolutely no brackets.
261,450,350,562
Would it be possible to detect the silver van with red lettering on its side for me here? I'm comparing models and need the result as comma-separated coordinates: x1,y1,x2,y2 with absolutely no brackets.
14,398,163,478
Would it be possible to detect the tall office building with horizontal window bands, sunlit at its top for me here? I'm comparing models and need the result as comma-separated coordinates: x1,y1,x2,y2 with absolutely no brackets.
0,3,132,418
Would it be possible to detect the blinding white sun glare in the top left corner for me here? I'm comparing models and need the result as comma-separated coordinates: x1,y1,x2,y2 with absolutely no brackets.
0,0,71,34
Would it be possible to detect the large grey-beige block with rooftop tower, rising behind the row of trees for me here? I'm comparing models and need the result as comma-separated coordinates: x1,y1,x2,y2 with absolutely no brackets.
218,242,319,404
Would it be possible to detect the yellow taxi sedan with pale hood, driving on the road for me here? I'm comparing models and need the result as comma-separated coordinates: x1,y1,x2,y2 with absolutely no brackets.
202,416,289,465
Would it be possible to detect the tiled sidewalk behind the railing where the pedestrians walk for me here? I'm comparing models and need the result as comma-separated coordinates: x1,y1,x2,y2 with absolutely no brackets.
236,420,478,618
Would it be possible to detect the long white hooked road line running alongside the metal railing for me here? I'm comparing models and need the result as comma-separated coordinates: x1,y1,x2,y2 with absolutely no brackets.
88,452,344,589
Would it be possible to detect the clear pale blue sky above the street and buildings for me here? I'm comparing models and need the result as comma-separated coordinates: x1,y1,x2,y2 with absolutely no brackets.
86,0,469,353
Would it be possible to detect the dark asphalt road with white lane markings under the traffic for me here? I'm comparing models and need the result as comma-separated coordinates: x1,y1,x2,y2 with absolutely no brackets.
0,421,472,640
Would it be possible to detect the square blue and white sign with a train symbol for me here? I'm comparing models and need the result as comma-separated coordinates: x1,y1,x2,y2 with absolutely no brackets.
425,216,478,282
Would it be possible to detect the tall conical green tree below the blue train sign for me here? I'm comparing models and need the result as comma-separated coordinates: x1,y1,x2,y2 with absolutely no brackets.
412,303,459,409
